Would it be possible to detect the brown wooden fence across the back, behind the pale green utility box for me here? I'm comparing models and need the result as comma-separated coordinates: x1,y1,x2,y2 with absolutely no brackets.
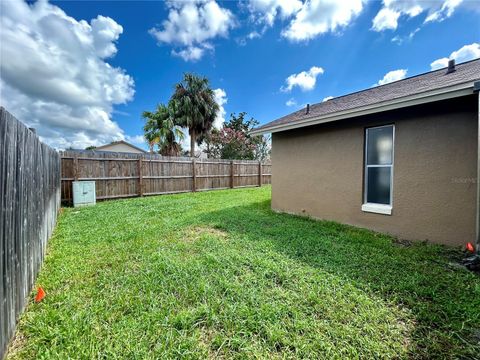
61,150,271,202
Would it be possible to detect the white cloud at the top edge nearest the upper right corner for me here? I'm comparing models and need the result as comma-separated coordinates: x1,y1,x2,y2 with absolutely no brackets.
372,0,463,31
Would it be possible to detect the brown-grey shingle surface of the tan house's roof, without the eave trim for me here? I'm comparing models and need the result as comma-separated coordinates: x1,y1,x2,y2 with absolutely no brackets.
254,59,480,132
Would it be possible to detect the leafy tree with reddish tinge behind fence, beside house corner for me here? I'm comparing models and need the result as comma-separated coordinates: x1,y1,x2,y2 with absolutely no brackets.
206,112,271,161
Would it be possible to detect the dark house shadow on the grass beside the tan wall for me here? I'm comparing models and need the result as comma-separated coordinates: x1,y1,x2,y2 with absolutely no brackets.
199,201,480,358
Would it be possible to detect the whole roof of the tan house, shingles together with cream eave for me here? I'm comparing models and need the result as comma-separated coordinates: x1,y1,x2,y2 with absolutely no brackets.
252,59,480,135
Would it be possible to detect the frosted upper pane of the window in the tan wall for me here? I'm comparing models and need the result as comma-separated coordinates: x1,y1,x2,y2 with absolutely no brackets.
367,126,393,165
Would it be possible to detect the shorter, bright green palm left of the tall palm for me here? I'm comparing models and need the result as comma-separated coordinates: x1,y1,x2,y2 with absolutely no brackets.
142,104,184,156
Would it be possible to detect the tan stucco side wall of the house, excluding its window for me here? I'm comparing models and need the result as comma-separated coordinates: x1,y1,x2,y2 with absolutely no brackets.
272,96,478,245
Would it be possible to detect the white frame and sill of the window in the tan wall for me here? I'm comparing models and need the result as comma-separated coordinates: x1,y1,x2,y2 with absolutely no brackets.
362,124,395,215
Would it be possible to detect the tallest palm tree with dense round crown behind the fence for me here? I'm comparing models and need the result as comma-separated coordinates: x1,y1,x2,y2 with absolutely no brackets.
169,73,219,157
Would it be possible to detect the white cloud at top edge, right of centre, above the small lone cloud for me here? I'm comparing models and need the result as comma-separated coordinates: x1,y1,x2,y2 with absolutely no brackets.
282,0,363,41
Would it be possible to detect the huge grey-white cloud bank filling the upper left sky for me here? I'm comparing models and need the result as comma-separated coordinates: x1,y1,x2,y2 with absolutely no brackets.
0,0,134,148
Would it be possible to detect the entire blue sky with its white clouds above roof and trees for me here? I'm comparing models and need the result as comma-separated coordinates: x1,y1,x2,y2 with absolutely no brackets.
1,0,480,148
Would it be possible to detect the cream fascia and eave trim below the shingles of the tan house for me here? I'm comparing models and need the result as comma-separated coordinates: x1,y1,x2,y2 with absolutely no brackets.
251,81,475,135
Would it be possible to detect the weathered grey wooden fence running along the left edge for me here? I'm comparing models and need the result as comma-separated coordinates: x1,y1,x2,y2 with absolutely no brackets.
0,107,60,359
